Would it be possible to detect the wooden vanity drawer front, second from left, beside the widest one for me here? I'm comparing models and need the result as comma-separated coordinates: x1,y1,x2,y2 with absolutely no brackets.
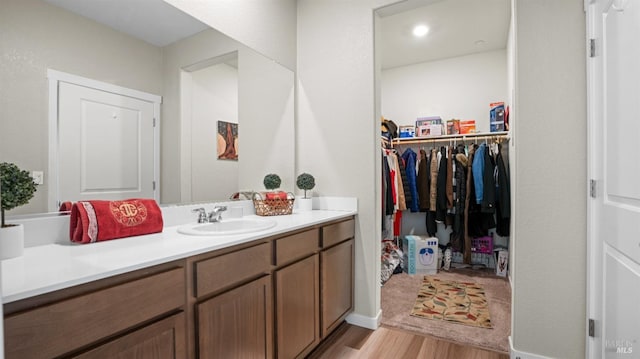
195,243,271,297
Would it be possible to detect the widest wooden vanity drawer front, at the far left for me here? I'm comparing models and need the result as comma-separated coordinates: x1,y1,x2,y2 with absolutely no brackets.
4,267,185,358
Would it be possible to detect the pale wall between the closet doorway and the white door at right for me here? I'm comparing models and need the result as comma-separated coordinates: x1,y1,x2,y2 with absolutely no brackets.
512,0,588,358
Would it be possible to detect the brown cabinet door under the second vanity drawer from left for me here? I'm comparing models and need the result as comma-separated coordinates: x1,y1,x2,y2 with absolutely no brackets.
197,276,273,359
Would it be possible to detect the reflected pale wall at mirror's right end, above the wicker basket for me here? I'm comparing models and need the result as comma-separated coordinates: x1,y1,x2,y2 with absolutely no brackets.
238,51,296,192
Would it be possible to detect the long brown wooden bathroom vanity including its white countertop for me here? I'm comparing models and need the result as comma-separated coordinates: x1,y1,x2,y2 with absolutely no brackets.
3,211,355,358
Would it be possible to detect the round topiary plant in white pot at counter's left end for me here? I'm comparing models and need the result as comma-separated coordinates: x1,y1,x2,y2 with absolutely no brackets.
0,162,36,259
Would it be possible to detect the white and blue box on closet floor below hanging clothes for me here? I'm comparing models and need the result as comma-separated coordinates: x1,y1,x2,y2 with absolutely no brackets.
402,235,438,274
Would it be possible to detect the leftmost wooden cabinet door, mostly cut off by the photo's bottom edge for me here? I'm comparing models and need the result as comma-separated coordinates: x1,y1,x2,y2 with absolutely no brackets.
73,313,186,359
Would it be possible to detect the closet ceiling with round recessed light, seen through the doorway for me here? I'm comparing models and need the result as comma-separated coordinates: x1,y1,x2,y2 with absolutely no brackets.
377,0,511,69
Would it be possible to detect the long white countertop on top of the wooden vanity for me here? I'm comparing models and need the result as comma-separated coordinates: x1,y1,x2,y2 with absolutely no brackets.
2,210,356,304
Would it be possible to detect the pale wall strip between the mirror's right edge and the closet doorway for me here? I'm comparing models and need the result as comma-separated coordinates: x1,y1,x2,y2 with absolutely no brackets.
296,0,398,328
